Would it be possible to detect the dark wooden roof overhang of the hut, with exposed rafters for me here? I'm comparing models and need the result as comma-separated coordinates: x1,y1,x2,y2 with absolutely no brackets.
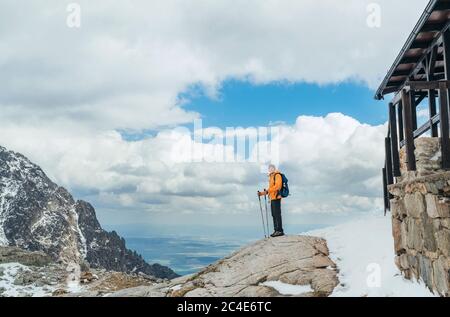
375,0,450,100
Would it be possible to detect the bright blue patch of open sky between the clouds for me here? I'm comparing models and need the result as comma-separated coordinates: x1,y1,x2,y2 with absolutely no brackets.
180,80,387,128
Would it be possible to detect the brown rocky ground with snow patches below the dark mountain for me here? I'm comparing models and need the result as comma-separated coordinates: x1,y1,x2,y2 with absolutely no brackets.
0,247,163,297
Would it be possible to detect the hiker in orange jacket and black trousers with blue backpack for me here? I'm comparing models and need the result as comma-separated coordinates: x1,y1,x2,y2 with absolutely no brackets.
258,164,289,238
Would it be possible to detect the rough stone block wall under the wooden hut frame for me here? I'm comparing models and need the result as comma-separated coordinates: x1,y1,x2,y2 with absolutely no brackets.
389,138,450,296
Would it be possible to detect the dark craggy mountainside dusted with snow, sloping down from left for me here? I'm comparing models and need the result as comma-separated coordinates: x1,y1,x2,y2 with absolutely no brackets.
0,147,177,278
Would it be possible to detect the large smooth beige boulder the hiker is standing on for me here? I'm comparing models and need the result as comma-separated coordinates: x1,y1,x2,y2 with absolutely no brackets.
109,236,339,297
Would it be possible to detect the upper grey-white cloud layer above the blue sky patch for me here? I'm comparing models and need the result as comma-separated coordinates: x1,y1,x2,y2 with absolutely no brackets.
0,0,427,130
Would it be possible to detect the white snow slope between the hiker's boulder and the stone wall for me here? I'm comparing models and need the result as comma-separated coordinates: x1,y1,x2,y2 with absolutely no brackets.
306,214,433,297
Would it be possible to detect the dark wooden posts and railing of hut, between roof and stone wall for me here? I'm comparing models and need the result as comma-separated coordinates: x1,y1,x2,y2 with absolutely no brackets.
383,80,450,213
